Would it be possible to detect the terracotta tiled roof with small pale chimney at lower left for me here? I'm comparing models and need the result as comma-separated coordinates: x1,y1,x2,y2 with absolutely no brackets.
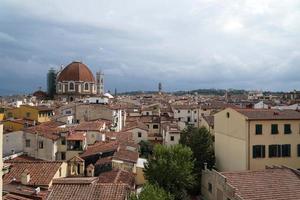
3,161,62,186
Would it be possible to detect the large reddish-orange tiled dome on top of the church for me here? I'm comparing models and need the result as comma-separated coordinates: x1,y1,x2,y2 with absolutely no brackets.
57,61,95,82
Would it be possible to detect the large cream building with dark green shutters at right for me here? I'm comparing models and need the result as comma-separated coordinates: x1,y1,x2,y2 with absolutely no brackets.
214,108,300,171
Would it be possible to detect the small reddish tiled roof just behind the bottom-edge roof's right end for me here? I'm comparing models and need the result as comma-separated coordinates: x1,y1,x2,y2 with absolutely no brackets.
98,169,135,188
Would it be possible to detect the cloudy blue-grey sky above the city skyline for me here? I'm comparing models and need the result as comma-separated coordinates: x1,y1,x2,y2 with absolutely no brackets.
0,0,300,95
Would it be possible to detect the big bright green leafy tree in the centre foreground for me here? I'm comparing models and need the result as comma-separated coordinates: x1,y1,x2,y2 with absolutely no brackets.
145,145,194,199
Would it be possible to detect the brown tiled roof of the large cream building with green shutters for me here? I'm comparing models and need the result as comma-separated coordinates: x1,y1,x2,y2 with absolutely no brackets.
234,109,300,120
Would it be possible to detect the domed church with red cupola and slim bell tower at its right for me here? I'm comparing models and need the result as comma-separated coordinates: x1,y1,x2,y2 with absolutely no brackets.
56,61,104,101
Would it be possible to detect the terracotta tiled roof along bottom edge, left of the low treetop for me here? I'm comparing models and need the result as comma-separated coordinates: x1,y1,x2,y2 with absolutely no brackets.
48,183,129,200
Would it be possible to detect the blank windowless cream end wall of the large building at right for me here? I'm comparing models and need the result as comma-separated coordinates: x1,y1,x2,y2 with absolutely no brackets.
215,108,248,171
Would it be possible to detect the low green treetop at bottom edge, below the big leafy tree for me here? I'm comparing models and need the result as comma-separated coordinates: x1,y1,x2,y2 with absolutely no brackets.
129,183,174,200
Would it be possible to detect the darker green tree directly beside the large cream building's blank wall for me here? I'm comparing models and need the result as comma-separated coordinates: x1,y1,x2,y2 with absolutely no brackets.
179,126,215,194
